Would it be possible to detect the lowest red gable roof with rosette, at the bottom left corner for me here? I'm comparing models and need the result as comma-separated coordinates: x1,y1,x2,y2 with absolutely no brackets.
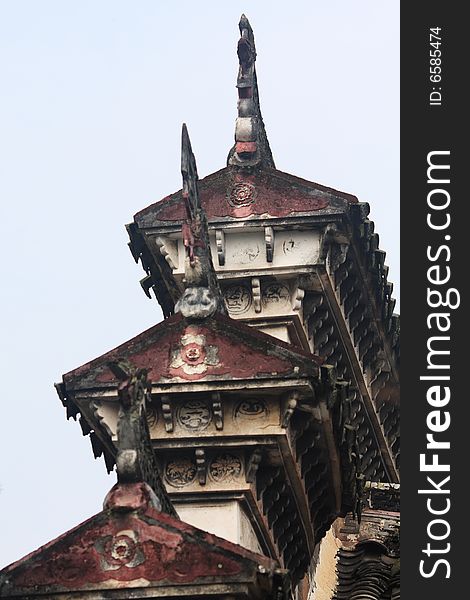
0,483,287,599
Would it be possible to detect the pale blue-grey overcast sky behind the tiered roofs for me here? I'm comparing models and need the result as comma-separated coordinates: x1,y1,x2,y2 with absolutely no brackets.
0,0,399,567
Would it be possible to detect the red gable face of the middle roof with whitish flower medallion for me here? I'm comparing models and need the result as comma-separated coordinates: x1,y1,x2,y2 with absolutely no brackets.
63,314,322,392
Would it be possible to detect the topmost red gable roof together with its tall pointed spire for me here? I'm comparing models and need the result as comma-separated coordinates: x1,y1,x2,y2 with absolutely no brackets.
135,15,357,228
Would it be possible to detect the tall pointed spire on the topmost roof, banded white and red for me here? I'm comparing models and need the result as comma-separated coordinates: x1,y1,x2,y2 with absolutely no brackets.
227,15,275,168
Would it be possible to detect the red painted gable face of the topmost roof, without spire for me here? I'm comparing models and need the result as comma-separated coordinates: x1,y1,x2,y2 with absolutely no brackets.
134,167,357,228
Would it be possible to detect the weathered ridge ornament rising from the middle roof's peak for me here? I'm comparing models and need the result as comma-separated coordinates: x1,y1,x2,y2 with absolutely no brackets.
175,123,227,319
